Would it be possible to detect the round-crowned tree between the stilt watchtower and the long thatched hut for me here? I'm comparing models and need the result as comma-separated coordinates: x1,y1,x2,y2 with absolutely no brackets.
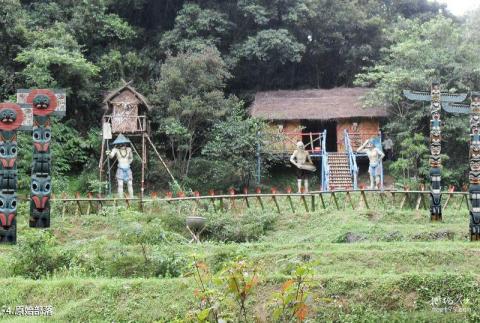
152,48,238,178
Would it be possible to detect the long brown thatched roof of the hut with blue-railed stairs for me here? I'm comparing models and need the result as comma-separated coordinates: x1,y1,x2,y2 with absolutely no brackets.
250,87,388,120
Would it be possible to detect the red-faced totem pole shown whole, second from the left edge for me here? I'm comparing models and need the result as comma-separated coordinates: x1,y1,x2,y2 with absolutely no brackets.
17,89,66,228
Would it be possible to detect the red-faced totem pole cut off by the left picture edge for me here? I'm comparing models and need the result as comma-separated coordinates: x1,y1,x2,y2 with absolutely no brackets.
0,103,32,243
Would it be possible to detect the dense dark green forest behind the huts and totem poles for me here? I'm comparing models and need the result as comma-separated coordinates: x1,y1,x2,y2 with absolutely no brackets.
0,0,480,191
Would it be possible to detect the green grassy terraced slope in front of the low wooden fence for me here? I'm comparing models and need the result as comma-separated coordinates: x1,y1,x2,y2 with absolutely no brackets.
0,201,480,322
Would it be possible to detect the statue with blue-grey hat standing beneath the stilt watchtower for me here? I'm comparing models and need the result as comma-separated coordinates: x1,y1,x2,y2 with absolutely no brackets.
106,135,133,198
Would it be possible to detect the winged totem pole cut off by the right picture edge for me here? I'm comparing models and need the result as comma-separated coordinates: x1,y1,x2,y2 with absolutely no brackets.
445,92,480,241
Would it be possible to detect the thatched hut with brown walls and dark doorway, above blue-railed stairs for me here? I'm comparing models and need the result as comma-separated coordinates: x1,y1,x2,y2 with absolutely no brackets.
250,87,388,151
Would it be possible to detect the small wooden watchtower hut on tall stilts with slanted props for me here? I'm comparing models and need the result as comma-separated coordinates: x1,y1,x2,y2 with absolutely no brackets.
99,82,175,199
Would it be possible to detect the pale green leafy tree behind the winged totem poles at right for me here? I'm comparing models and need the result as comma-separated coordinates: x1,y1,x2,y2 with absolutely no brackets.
356,15,480,184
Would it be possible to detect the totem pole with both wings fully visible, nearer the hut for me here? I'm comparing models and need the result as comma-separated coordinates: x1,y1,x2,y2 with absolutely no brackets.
403,82,467,221
